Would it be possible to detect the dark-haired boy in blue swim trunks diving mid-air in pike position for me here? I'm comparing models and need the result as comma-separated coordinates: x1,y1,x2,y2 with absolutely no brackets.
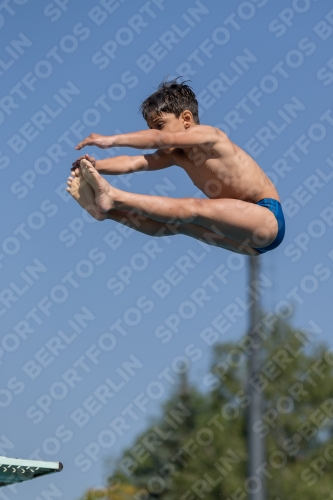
67,80,285,255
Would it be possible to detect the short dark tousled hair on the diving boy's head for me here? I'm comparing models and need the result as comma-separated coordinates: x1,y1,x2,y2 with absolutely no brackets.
140,78,200,124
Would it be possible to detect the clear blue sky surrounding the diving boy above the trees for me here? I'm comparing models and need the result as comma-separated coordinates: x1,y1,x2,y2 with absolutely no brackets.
0,0,333,500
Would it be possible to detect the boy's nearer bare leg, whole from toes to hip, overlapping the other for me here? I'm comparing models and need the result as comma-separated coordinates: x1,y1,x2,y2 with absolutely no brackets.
81,160,278,248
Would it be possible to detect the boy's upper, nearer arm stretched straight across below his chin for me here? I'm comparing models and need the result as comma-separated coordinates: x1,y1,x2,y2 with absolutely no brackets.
76,125,220,150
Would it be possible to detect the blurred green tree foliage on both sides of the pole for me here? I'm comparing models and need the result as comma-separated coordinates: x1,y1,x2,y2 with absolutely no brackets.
81,317,333,500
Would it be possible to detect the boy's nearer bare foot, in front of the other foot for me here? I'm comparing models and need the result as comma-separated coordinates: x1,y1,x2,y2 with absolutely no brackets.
80,159,115,213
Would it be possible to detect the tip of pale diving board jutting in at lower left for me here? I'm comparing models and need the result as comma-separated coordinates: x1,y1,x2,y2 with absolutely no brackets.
0,457,63,488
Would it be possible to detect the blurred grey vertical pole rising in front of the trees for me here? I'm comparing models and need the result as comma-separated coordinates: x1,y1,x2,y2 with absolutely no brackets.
247,257,266,500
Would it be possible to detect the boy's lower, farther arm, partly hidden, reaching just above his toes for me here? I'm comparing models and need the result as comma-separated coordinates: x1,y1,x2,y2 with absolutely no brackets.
72,151,173,175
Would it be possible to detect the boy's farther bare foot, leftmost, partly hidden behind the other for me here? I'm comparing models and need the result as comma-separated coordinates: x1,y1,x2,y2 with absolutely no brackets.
66,172,106,220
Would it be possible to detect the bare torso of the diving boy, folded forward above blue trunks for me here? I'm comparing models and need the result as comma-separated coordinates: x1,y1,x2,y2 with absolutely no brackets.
169,132,280,203
